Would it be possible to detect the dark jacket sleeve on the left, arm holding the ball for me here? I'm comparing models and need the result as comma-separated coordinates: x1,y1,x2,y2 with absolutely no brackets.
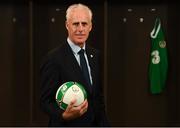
40,55,64,125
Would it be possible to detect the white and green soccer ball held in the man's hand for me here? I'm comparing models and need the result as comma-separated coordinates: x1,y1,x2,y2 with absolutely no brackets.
56,81,87,110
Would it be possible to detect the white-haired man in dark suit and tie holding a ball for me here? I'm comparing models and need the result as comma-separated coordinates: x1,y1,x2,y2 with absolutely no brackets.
40,4,108,126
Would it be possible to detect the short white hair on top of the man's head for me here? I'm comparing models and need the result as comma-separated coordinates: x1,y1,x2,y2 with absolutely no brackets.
66,3,92,20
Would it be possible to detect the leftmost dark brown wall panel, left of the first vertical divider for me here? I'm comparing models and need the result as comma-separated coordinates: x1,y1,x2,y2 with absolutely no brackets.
0,3,30,126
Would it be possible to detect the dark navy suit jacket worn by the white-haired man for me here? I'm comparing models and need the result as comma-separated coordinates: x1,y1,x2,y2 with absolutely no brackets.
40,42,109,126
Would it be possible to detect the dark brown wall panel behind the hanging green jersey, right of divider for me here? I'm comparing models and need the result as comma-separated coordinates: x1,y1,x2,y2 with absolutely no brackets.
107,4,179,126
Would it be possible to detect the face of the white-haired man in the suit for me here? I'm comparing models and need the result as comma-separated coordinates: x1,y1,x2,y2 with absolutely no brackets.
66,8,92,47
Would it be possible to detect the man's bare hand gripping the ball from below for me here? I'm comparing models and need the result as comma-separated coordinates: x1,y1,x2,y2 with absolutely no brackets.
62,100,88,120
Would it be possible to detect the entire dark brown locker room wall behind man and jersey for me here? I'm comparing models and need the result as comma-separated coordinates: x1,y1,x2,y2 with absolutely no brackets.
0,0,180,126
